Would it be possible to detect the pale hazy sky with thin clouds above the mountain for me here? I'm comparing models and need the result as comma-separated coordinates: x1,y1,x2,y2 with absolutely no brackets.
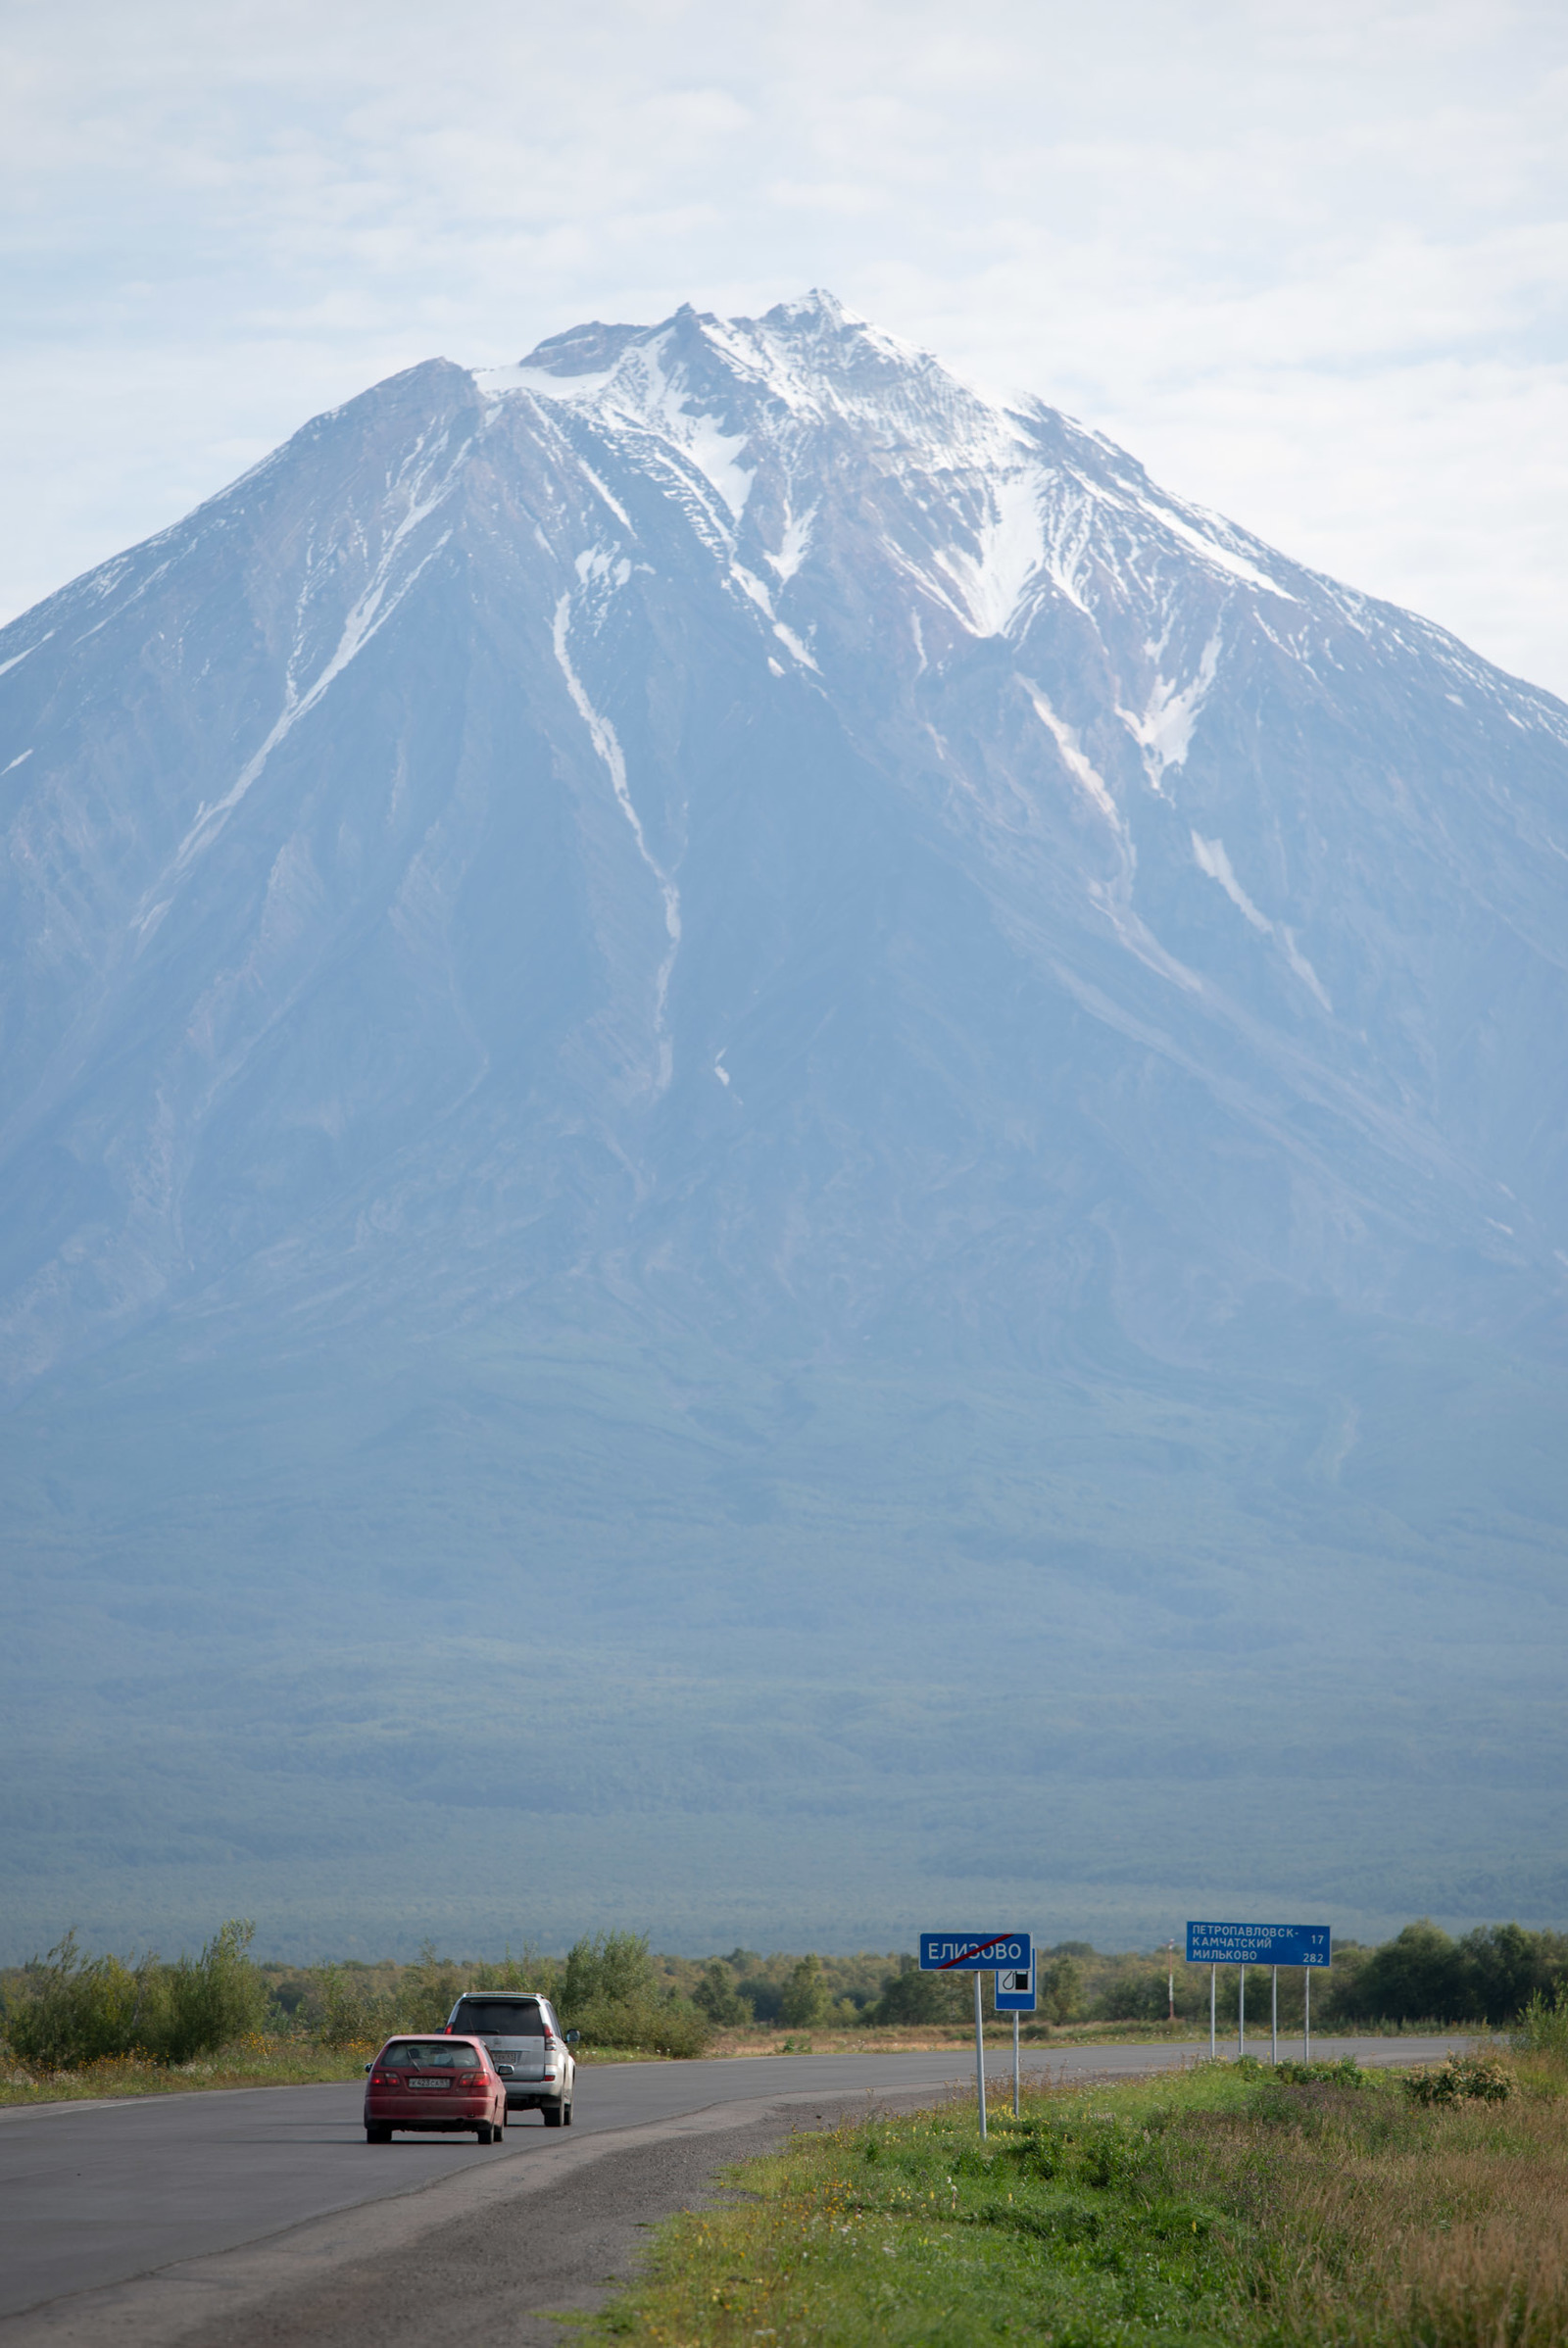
0,0,1568,695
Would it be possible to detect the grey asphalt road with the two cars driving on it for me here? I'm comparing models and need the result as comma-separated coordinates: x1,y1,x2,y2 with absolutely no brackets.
0,2038,1460,2348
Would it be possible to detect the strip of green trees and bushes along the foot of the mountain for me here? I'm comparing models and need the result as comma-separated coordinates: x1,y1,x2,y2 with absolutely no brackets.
0,1919,1568,2071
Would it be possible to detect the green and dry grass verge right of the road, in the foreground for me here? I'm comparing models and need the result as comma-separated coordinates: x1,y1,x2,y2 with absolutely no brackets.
589,2059,1568,2348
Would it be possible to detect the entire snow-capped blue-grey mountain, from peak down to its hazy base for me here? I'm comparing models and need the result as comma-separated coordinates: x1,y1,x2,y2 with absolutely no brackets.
0,296,1568,1946
